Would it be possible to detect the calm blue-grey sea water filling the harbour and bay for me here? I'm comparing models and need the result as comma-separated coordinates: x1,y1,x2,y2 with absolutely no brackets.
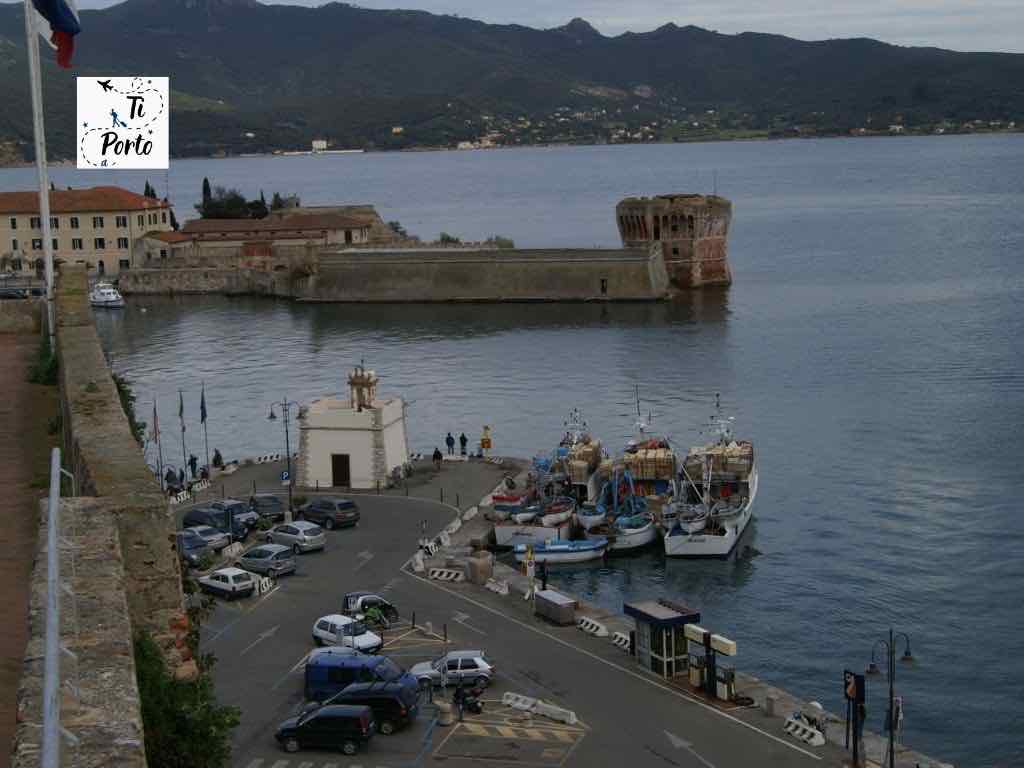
0,135,1024,766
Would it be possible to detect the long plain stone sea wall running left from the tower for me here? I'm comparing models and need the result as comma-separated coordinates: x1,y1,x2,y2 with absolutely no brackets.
307,248,667,302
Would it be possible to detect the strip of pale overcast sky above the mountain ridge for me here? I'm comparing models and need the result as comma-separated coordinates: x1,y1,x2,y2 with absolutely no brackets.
79,0,1024,53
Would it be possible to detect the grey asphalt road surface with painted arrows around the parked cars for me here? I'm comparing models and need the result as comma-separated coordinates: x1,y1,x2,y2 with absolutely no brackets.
203,496,842,768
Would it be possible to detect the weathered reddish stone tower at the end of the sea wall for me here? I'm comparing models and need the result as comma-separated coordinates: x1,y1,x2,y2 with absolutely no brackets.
615,195,732,291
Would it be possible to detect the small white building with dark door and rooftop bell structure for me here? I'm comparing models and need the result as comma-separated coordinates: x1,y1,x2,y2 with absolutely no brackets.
298,366,409,488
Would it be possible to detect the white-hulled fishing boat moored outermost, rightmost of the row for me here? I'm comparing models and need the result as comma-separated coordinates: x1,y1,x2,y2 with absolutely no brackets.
665,396,758,558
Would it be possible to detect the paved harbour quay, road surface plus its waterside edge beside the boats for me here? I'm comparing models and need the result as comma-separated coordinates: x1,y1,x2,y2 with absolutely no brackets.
178,459,944,768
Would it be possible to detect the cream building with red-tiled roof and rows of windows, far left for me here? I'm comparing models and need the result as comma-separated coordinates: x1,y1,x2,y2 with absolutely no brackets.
0,186,172,278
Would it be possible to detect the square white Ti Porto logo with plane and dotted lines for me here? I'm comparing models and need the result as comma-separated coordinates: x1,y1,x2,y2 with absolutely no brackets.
76,76,171,169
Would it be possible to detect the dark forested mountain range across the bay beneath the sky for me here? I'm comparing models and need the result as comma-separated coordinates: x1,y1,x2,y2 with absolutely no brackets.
0,0,1024,158
